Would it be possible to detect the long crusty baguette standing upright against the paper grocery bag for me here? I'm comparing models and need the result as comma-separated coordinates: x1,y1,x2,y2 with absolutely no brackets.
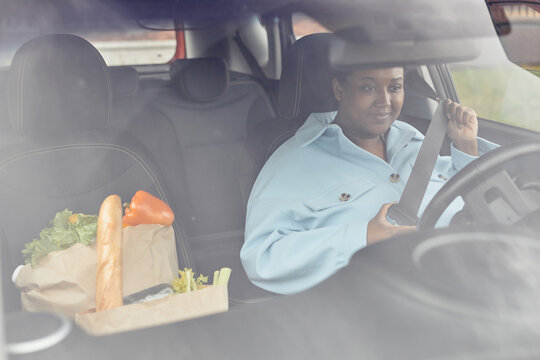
96,195,122,311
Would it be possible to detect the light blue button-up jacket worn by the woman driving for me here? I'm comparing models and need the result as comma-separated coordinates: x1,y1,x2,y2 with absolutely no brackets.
240,112,496,294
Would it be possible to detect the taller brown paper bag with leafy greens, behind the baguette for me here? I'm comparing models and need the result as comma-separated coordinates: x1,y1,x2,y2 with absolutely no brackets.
13,191,178,316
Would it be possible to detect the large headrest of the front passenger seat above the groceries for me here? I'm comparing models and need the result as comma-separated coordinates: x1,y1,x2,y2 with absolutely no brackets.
7,35,111,136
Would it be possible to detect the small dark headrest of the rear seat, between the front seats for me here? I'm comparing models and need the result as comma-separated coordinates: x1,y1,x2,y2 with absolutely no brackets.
170,57,229,102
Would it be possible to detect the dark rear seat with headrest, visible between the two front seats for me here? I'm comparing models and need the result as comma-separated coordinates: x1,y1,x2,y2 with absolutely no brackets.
124,58,275,303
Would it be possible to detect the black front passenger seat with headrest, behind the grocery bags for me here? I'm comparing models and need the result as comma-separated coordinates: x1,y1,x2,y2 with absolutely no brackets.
0,35,193,310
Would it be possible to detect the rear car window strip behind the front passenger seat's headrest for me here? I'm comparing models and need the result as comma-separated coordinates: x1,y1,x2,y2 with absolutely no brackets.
0,20,176,66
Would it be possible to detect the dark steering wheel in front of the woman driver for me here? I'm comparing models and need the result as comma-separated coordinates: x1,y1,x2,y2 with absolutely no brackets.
418,141,540,230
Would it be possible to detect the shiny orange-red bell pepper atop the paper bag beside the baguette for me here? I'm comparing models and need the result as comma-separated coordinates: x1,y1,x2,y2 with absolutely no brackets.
123,190,174,227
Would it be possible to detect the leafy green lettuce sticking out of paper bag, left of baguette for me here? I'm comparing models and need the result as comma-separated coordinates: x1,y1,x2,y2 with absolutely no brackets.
22,209,97,266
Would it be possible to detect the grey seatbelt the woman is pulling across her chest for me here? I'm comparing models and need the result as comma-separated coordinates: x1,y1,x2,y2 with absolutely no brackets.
387,72,448,225
